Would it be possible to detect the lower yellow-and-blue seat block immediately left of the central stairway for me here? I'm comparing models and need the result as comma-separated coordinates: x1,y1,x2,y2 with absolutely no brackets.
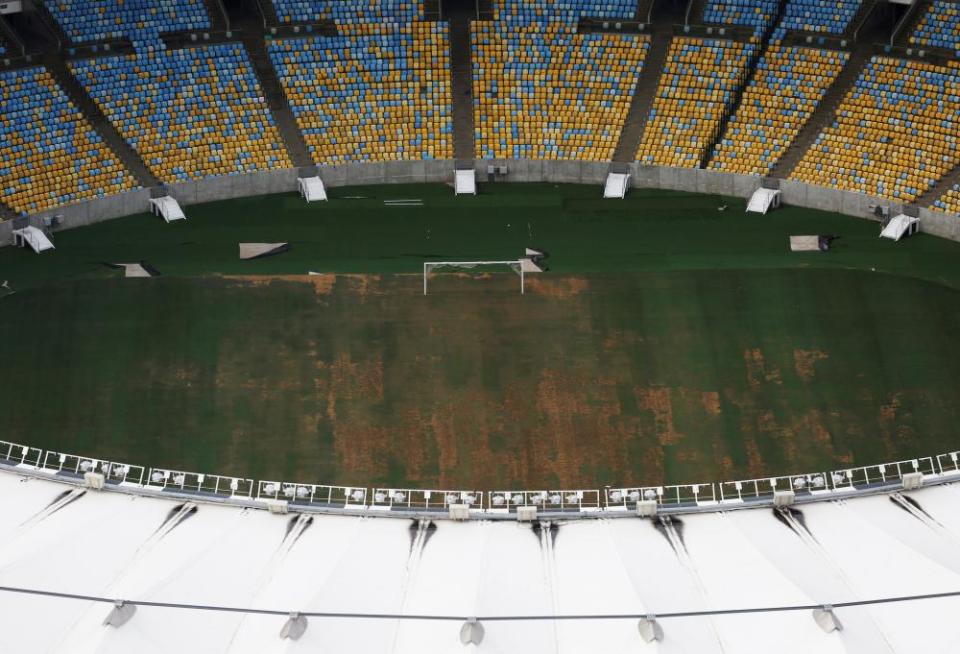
268,23,453,164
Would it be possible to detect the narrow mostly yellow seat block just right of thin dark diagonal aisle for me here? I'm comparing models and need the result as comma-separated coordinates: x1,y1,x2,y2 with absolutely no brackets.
708,45,849,175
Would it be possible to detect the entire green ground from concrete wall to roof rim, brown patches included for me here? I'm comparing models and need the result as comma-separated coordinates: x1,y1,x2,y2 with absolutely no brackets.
0,184,960,489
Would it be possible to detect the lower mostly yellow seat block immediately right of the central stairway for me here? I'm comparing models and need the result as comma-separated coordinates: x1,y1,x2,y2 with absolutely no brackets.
473,22,649,161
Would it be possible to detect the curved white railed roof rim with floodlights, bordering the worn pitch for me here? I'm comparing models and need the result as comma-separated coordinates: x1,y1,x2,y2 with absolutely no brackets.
0,441,960,520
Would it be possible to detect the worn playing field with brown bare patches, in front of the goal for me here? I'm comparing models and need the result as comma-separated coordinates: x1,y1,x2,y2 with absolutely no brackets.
0,270,960,488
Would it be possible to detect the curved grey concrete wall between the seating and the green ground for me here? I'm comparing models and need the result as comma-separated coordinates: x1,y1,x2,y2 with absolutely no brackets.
0,159,960,245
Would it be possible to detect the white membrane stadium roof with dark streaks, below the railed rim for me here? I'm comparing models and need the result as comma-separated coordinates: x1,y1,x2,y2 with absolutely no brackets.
0,444,960,654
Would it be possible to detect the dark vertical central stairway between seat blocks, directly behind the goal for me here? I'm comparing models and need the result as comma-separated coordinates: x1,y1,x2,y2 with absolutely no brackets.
443,2,476,161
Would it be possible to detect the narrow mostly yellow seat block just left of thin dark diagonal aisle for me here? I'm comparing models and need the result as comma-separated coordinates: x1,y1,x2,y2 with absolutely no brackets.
637,37,756,168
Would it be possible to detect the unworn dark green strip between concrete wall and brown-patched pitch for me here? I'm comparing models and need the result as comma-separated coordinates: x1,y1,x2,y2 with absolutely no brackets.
0,184,960,288
